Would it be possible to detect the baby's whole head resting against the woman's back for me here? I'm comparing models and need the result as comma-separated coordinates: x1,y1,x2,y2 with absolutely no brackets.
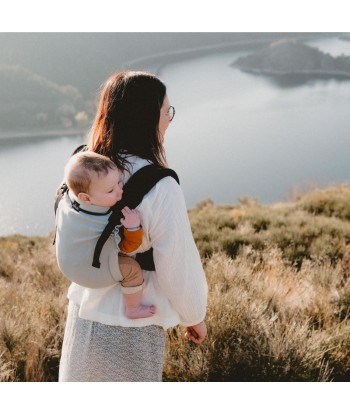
64,151,123,207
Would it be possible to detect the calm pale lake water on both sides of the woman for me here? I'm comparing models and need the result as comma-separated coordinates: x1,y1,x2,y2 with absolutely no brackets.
0,38,350,235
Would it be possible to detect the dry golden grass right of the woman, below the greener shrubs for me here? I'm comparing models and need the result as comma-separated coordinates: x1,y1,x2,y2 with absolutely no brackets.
165,249,350,381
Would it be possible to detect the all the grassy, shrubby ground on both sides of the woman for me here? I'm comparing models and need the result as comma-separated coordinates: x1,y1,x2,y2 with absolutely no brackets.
0,187,350,382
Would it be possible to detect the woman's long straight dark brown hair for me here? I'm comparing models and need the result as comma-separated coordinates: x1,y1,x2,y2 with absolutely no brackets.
89,71,167,170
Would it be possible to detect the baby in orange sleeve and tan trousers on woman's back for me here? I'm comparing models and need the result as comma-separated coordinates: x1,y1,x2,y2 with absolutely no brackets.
65,151,155,319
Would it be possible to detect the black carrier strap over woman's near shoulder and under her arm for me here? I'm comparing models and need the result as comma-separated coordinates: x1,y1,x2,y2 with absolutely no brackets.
92,164,180,270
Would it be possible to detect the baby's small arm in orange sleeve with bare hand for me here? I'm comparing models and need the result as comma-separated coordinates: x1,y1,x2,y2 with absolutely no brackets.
119,206,143,254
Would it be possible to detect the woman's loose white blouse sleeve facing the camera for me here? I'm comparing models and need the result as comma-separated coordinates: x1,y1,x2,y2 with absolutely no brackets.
149,177,207,326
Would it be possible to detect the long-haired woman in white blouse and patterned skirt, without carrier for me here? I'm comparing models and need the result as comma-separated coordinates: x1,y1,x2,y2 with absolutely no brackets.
59,71,207,381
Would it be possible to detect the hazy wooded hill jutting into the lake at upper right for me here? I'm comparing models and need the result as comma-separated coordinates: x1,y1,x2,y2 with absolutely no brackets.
232,39,350,77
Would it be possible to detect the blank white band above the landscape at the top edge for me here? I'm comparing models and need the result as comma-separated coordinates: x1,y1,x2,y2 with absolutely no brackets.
0,0,348,32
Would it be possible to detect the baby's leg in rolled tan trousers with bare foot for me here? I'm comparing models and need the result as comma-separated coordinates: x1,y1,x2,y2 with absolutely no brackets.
119,255,156,319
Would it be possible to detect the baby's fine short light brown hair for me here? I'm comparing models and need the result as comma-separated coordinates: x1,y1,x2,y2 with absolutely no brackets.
64,151,117,195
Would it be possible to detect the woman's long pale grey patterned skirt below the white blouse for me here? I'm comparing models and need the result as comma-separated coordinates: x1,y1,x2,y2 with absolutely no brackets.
59,302,166,382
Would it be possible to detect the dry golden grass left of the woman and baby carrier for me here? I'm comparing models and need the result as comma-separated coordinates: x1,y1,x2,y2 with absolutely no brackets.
0,236,68,381
